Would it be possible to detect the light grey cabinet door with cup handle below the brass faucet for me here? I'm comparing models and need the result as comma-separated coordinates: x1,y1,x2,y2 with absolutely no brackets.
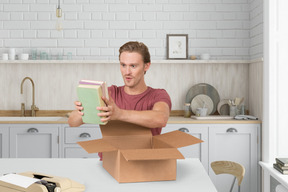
10,124,59,158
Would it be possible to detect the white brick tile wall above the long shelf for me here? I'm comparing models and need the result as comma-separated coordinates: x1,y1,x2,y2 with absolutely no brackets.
0,0,256,60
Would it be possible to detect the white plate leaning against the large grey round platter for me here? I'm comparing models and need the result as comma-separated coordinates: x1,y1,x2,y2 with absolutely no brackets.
191,94,214,115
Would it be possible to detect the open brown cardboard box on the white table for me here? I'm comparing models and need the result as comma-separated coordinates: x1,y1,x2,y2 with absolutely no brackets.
78,121,203,183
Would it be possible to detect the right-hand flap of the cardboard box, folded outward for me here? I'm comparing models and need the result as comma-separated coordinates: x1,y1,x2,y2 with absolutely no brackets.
153,130,203,148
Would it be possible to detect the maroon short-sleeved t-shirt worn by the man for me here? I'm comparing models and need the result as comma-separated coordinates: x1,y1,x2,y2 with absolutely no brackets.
108,85,171,135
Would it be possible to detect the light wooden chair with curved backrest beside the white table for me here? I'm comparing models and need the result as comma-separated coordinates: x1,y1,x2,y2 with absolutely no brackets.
211,161,245,192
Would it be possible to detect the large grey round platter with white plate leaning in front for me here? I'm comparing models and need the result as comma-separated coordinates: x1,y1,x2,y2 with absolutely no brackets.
186,83,220,115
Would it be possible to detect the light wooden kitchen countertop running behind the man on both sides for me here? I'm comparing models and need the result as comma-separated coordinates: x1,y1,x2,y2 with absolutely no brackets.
0,116,261,124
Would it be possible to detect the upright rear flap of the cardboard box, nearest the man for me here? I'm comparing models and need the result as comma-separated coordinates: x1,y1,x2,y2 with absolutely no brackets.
100,121,152,138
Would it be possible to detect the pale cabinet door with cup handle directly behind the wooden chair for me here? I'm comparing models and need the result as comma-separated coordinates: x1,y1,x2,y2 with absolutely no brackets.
209,124,259,192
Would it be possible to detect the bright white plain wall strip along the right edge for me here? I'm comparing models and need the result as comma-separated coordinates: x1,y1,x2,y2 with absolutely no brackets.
262,0,288,163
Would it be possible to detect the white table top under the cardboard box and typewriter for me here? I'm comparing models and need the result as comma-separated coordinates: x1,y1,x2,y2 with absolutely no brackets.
0,158,217,192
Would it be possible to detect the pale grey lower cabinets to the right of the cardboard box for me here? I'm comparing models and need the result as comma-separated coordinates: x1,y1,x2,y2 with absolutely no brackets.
162,124,260,192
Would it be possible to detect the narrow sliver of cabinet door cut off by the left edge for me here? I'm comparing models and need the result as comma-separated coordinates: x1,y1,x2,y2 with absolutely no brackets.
0,125,9,158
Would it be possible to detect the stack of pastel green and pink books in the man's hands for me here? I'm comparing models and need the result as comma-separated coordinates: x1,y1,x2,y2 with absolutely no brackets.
77,80,108,125
